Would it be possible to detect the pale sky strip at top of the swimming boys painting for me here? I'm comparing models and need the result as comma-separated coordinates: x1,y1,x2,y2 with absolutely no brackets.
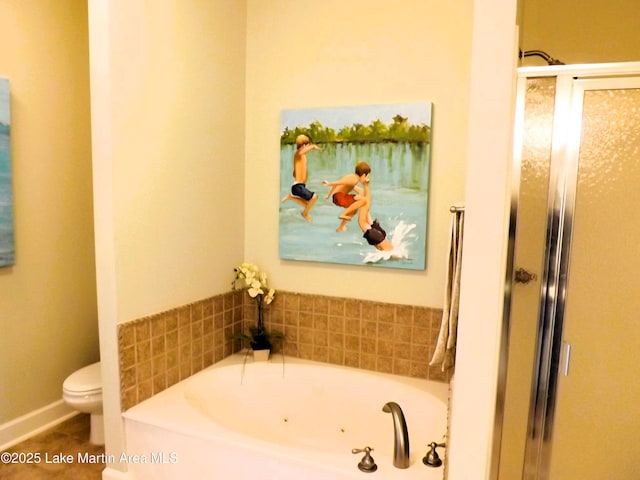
281,102,431,130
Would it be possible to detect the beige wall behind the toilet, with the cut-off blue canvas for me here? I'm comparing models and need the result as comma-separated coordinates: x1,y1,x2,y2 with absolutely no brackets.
0,0,98,422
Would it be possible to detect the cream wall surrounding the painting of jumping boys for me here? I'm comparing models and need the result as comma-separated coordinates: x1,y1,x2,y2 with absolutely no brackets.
244,0,473,307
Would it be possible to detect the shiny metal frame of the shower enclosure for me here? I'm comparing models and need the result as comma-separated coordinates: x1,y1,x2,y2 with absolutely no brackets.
494,62,640,480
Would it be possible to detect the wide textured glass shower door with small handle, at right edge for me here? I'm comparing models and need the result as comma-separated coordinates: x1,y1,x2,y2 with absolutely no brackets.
539,78,640,480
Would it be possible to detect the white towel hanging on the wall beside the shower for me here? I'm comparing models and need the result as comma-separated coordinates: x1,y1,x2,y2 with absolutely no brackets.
429,208,464,372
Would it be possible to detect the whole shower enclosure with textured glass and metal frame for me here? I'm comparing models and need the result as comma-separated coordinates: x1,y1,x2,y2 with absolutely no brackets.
495,63,640,480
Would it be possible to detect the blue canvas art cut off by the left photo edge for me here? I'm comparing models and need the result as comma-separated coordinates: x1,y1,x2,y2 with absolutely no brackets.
0,78,15,267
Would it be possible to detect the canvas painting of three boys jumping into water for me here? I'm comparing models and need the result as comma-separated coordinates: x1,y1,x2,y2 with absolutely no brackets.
279,102,432,270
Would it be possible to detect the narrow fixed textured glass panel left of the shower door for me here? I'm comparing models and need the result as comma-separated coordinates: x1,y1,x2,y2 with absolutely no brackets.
499,77,556,479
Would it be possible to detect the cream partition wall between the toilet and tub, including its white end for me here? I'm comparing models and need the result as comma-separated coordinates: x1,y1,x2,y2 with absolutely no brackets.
89,0,246,469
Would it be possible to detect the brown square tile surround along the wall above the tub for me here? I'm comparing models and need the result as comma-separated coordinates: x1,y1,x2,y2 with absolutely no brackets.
118,290,452,411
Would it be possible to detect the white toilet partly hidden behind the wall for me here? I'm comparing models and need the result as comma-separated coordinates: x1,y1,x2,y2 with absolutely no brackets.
62,362,104,445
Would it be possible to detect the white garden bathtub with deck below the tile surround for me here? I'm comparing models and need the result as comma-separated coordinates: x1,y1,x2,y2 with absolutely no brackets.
124,354,448,480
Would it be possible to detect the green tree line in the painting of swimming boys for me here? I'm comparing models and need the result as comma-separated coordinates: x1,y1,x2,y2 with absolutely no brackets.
280,115,431,145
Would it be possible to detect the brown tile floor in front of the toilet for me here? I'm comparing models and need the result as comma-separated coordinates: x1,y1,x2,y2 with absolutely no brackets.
0,414,104,480
